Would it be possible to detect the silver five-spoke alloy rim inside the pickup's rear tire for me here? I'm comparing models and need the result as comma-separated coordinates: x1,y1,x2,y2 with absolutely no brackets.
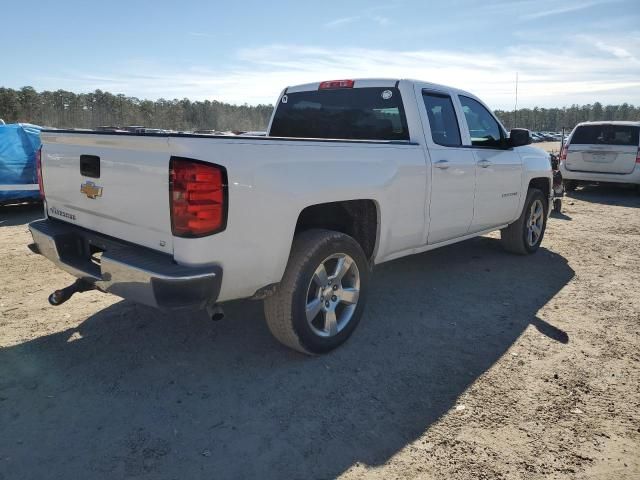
306,253,360,337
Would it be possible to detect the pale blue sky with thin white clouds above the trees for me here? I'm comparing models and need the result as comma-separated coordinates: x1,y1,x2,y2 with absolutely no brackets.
0,0,640,109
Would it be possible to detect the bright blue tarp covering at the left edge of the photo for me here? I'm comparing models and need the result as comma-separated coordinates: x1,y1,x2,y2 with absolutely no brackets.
0,123,40,203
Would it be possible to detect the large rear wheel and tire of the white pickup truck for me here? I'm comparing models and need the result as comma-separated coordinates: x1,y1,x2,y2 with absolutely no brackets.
264,230,370,355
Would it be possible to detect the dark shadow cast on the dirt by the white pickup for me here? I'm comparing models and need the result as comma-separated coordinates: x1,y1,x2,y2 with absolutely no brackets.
0,237,574,479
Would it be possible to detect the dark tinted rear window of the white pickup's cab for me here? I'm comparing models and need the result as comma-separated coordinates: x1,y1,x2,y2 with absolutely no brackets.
269,87,409,140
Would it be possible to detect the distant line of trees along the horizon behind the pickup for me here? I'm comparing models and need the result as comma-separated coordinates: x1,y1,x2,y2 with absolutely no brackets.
0,87,640,131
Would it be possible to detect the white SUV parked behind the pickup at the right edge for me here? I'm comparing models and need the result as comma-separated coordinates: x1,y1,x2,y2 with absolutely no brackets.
560,122,640,191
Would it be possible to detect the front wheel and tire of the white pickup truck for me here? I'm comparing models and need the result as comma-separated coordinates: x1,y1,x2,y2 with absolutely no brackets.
500,188,548,255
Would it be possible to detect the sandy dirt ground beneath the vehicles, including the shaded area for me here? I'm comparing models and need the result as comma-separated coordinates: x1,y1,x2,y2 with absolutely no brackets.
0,187,640,480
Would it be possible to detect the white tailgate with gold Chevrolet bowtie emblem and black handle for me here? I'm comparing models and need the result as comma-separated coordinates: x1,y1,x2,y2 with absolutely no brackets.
42,132,173,253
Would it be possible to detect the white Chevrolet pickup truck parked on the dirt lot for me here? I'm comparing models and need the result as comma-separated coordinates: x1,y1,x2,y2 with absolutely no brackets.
30,79,552,354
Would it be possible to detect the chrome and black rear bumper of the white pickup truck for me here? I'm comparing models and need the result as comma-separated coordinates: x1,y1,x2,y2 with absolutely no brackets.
29,219,222,308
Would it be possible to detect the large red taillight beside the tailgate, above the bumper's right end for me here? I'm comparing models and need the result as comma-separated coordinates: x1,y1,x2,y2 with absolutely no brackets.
169,157,227,237
